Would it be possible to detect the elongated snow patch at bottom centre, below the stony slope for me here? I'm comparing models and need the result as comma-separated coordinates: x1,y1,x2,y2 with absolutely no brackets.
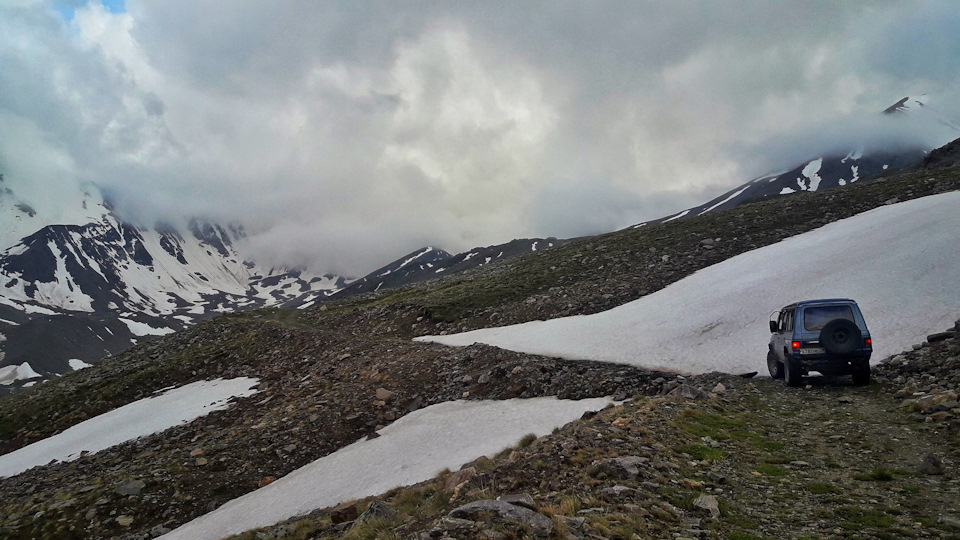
161,398,610,540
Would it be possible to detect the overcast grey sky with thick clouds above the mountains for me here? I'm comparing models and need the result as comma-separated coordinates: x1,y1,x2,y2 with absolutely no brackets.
0,0,960,276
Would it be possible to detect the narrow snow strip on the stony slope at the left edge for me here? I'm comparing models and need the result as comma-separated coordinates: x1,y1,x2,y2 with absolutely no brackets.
0,377,260,478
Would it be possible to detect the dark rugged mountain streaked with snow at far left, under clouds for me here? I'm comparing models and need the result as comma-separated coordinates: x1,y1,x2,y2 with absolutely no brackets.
0,182,346,391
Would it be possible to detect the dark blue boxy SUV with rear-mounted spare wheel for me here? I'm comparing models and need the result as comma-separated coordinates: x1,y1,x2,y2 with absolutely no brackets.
767,298,873,386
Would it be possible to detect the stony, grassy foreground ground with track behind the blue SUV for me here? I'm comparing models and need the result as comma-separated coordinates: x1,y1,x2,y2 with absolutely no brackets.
231,320,960,539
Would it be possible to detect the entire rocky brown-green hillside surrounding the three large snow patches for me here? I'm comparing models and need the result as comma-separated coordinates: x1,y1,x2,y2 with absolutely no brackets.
0,162,960,538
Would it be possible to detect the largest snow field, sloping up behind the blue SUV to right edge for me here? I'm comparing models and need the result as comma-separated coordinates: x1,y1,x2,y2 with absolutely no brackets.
417,192,960,373
